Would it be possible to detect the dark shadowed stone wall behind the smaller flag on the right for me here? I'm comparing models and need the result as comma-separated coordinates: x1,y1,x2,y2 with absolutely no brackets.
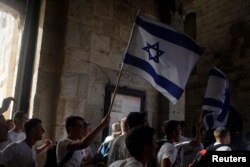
184,0,250,137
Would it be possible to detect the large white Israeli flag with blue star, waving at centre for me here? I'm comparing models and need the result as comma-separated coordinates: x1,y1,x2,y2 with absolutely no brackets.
124,16,203,104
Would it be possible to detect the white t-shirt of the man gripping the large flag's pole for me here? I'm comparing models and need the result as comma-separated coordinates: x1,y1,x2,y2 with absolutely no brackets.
56,138,83,167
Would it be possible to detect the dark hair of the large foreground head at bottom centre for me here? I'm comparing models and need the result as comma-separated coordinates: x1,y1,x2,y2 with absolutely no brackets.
125,126,155,158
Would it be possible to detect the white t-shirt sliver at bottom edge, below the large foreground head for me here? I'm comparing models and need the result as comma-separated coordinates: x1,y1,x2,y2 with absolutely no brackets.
109,157,144,167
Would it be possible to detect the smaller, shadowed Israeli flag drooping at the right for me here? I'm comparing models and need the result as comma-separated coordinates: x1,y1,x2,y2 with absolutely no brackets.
202,67,230,130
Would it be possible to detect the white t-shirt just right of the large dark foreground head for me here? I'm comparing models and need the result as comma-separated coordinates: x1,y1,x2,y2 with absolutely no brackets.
157,142,178,164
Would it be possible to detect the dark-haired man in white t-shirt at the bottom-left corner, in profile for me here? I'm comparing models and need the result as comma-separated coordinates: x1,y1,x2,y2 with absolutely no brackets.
0,118,45,167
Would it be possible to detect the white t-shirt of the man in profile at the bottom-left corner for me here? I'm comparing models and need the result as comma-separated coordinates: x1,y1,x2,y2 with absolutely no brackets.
0,141,36,167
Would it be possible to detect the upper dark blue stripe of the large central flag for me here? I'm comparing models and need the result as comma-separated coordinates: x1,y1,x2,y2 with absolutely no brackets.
135,17,203,55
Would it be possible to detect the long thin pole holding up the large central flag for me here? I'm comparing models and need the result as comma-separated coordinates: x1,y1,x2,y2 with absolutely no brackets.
107,9,140,115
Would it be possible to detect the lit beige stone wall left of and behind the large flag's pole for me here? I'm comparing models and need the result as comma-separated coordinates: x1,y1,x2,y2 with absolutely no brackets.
36,0,162,150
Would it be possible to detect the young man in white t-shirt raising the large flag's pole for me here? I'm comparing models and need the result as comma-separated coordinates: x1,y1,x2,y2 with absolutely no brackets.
56,115,110,167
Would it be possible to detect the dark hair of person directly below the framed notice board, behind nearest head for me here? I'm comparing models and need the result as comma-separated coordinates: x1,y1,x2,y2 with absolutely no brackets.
126,112,147,129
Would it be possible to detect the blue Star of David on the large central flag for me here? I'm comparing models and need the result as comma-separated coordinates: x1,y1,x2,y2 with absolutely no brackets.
142,42,164,63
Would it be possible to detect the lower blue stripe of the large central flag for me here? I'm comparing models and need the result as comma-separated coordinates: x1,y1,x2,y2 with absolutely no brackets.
124,53,183,99
